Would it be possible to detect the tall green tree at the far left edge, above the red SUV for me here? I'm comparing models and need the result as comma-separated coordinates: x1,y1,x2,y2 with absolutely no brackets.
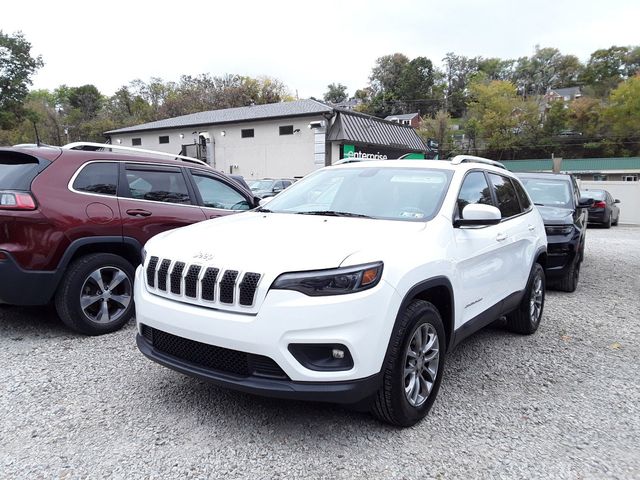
0,30,44,128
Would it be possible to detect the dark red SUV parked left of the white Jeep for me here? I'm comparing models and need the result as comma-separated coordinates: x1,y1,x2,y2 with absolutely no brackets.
0,144,258,335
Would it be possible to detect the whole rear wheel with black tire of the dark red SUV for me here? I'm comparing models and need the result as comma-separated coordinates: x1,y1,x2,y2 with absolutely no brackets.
55,253,134,335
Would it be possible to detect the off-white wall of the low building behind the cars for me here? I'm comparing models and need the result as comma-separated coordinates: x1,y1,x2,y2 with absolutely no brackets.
111,116,324,179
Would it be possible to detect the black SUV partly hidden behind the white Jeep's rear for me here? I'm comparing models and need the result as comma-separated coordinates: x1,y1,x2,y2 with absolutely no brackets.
518,173,593,292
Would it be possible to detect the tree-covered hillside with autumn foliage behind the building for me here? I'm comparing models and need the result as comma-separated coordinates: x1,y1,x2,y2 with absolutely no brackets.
0,31,640,159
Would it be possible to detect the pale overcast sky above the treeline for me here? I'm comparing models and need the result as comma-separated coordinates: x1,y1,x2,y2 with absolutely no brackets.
5,0,640,98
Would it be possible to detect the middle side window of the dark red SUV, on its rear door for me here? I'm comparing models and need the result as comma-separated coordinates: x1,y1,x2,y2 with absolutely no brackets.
126,166,192,205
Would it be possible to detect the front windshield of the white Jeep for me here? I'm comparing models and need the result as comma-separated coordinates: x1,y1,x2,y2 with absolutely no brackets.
266,167,452,220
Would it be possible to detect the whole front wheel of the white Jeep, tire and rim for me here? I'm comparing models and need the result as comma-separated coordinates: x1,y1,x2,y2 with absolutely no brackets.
372,300,446,427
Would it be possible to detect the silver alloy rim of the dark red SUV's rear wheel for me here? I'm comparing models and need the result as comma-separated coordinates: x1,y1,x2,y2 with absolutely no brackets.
80,267,132,323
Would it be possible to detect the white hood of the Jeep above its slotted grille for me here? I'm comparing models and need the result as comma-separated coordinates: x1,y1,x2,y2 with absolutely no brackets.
145,212,426,274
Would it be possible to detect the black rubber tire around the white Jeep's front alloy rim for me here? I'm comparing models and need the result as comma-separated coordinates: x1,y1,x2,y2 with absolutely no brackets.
371,300,446,427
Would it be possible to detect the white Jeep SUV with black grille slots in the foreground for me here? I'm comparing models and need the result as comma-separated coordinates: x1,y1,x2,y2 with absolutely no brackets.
135,157,547,426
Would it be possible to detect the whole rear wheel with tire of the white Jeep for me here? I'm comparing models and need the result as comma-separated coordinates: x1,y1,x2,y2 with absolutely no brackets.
507,263,546,335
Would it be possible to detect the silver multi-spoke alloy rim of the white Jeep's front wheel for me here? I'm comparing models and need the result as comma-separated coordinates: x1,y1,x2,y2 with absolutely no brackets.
404,323,440,407
